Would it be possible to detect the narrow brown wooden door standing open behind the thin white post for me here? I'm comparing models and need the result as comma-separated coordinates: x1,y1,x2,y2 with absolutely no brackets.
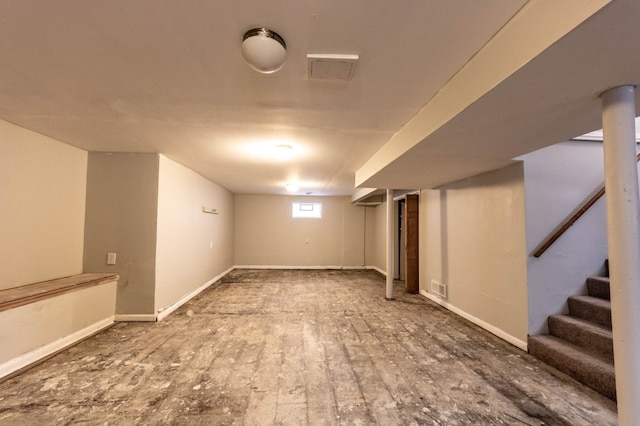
403,194,420,293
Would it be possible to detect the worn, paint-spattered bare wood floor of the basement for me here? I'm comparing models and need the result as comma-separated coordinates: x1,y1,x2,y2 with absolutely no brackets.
0,270,617,425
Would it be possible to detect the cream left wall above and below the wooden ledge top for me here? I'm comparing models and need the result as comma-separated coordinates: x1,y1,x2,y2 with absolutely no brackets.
0,120,116,377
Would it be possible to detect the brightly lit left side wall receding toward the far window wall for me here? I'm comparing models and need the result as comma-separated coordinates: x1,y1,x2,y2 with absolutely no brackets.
155,155,234,310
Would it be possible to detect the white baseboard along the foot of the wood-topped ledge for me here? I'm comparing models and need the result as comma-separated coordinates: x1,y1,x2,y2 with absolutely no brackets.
0,316,114,378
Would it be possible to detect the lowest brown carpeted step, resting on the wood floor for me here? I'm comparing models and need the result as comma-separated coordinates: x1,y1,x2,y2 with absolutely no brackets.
529,334,616,400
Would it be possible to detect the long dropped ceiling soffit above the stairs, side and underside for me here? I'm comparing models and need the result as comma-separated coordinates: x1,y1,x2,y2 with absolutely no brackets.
356,0,640,189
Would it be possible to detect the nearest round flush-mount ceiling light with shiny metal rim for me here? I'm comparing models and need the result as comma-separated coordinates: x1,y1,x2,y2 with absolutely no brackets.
242,28,287,74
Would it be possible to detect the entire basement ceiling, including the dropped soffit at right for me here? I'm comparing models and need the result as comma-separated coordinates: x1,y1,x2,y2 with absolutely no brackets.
0,0,640,195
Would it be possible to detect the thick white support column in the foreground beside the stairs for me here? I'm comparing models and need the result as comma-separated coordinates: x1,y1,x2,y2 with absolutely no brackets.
602,86,640,425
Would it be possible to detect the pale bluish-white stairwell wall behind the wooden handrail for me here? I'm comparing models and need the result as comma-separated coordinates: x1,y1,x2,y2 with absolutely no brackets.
520,141,608,334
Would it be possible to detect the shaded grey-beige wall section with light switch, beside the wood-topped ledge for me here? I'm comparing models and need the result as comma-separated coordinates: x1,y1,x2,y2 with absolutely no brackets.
84,152,159,315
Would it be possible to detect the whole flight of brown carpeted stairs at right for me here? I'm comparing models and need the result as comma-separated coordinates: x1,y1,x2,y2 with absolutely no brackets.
529,277,616,401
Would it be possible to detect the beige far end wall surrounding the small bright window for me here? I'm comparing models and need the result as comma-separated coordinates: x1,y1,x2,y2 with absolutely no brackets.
235,194,365,267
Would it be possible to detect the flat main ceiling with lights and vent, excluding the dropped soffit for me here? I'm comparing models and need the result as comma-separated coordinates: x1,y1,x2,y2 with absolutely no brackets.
0,0,526,195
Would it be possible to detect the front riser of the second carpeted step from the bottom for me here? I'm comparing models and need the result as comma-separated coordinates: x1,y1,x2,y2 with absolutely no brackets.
548,316,613,362
